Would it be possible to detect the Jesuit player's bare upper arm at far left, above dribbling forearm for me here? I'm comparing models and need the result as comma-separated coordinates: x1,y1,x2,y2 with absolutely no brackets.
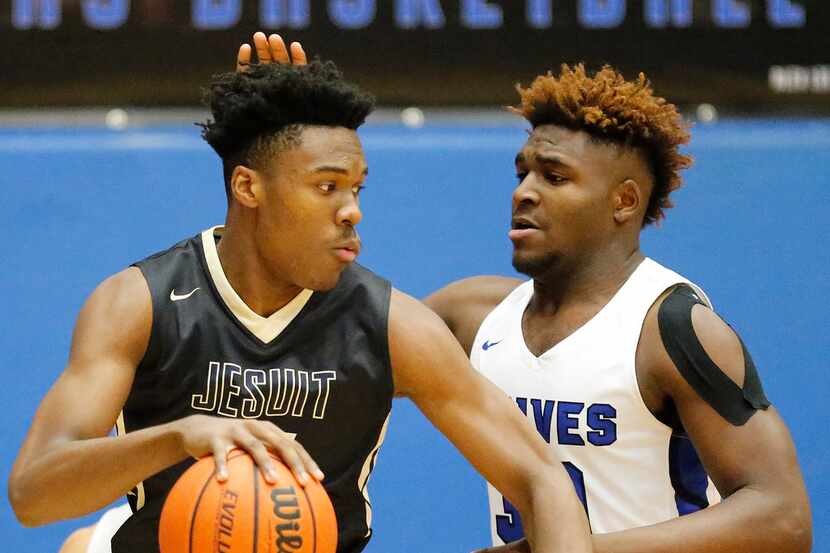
13,268,152,464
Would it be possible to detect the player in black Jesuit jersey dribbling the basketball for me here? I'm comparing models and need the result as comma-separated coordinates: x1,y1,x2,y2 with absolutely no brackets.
9,35,590,553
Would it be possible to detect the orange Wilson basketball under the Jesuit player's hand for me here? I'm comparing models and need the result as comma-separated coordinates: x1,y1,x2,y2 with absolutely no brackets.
159,449,337,553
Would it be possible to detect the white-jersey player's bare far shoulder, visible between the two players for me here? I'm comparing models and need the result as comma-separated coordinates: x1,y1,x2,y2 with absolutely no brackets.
424,276,522,353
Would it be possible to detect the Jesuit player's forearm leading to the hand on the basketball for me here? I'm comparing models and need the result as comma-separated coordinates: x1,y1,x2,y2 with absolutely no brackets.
9,423,187,526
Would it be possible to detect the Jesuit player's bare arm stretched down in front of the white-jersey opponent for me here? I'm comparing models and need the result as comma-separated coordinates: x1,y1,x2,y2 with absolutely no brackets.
389,291,590,553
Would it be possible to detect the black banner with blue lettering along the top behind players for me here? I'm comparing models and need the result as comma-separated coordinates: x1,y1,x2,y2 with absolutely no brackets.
0,0,830,112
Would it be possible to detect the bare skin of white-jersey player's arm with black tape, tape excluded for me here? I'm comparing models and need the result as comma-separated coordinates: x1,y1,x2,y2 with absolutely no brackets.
616,302,812,553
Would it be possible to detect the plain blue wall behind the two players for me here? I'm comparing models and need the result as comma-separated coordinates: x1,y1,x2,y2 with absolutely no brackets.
0,120,830,553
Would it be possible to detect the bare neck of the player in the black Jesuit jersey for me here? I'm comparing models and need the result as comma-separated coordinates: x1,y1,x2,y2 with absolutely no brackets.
216,222,303,317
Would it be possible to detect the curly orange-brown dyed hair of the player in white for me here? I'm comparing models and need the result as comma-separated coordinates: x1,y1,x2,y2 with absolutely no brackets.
510,63,692,226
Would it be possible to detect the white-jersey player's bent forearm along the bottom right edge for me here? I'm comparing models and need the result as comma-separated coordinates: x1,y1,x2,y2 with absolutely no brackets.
593,488,812,553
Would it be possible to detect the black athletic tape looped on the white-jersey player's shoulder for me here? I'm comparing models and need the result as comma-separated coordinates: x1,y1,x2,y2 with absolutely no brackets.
657,285,770,426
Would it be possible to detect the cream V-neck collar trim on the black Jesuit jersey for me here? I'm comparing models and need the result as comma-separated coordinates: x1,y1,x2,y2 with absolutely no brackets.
202,226,312,344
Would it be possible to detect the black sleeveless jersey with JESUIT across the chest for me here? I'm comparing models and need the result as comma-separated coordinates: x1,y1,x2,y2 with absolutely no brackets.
112,229,393,553
